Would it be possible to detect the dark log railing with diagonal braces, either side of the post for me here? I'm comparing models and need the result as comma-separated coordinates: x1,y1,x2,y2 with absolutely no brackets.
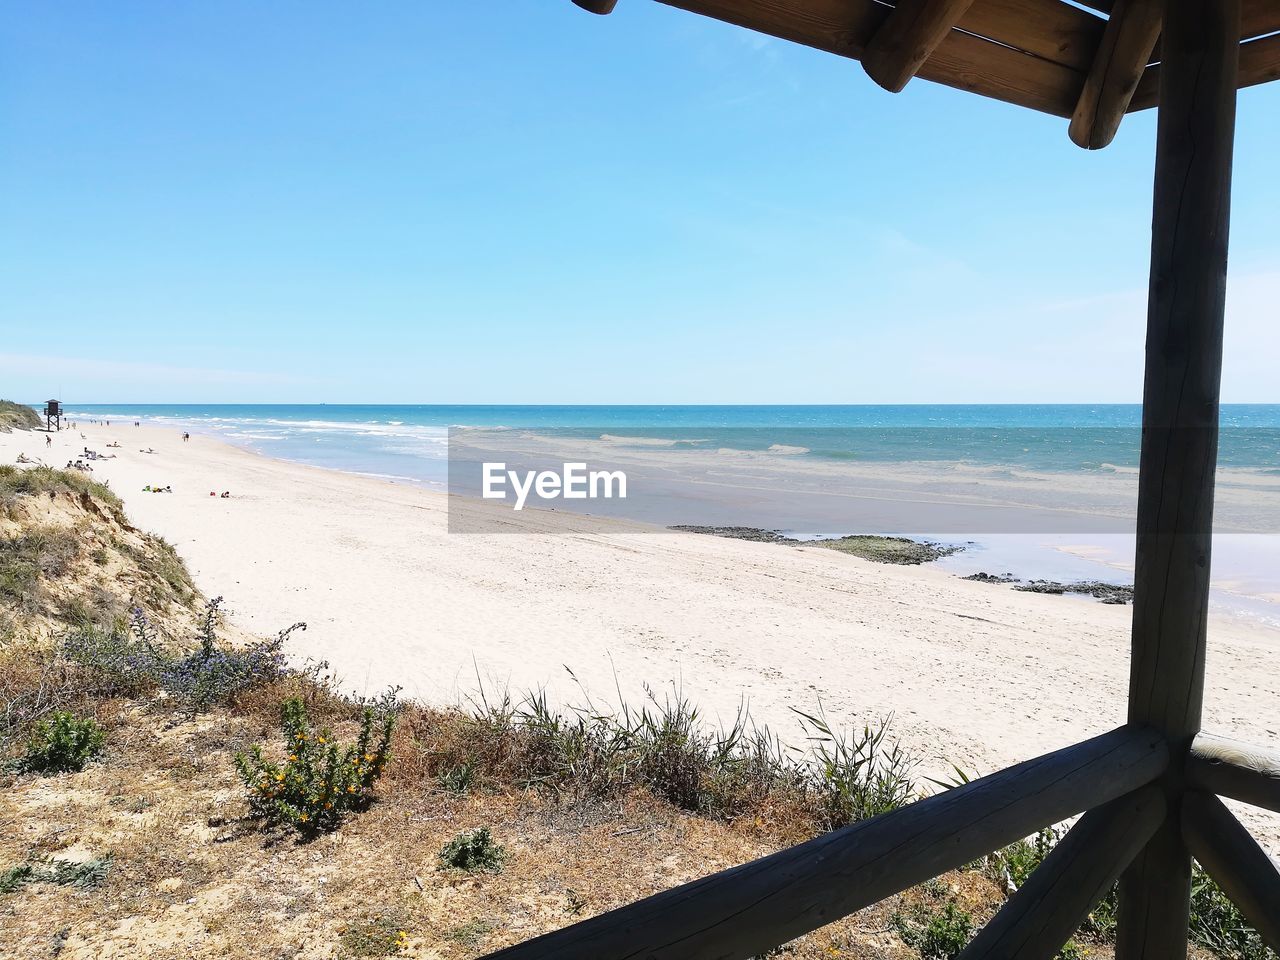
489,726,1280,960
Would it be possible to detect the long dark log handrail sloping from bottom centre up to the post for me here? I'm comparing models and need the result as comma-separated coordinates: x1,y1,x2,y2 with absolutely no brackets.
481,727,1169,960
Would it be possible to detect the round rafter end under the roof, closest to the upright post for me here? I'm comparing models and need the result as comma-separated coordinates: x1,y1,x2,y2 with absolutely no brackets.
1068,0,1164,150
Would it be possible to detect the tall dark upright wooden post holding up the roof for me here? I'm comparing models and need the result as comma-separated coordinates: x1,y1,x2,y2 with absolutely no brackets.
1116,0,1240,960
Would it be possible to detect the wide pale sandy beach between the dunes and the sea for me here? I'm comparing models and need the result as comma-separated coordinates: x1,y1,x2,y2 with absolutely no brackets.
0,425,1280,850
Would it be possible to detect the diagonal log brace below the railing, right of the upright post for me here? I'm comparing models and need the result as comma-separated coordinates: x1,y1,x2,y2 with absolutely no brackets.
1183,794,1280,952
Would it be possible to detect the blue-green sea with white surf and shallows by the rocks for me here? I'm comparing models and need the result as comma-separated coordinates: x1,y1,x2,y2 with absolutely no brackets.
65,403,1280,628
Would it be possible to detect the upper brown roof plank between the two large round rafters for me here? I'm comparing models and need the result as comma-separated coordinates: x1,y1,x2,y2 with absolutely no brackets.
960,0,1106,72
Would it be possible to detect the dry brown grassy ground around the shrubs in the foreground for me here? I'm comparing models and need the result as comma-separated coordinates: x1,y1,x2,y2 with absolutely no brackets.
0,690,931,957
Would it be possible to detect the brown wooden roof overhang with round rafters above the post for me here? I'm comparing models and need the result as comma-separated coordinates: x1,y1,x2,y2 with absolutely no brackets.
573,0,1280,148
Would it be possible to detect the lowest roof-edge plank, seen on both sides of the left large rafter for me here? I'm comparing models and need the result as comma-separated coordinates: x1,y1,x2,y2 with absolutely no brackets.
659,0,1082,116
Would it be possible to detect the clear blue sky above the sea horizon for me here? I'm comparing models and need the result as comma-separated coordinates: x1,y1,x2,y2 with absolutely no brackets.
0,0,1280,403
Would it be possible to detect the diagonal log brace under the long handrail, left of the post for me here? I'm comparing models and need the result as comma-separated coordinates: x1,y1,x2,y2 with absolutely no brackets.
959,787,1166,960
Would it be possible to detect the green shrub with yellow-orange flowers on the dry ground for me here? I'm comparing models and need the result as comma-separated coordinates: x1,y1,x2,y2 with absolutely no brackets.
236,696,396,835
